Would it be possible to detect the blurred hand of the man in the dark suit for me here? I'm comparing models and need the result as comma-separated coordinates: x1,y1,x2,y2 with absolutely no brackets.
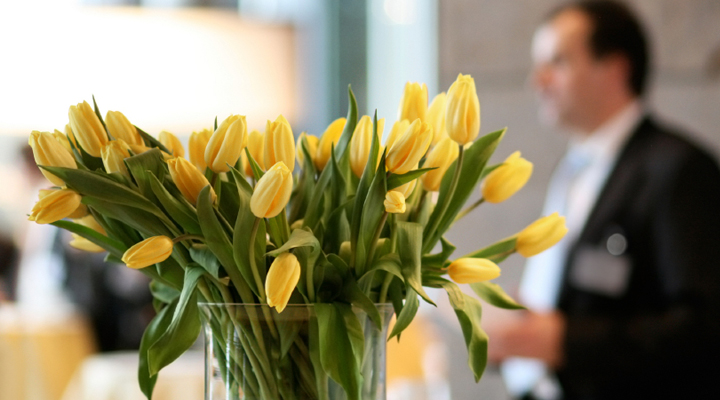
486,312,565,368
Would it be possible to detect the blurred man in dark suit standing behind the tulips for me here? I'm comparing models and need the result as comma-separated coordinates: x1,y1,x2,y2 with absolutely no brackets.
488,1,720,400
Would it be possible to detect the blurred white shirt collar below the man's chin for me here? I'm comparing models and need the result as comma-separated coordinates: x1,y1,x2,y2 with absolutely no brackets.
568,100,645,162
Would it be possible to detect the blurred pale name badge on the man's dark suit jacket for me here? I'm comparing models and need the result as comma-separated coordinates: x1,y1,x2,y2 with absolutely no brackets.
569,235,632,297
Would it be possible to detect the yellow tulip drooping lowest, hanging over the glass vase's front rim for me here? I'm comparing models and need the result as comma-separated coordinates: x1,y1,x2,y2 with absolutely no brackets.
265,253,300,313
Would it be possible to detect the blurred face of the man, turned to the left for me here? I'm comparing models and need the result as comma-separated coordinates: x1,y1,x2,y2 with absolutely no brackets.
532,9,607,131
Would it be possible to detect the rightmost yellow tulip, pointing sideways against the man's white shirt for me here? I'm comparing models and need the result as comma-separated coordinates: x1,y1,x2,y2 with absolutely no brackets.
515,213,567,257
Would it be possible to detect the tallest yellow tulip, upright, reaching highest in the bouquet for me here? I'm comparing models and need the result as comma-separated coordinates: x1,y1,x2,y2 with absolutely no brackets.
445,74,480,145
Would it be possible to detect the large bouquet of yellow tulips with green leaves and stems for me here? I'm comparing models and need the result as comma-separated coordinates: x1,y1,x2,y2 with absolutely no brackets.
30,75,566,399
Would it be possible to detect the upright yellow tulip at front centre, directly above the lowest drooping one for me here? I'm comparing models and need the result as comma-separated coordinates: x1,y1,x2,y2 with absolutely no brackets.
250,161,293,218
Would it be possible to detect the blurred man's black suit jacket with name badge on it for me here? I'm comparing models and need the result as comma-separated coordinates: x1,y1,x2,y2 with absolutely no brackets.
557,118,720,399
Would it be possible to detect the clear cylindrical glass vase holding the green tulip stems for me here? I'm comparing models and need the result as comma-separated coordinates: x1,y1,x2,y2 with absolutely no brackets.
200,303,393,400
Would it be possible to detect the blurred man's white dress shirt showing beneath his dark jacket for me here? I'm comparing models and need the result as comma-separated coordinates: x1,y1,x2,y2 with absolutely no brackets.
502,101,644,399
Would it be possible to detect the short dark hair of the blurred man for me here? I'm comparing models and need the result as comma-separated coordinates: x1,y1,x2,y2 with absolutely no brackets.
548,0,650,96
